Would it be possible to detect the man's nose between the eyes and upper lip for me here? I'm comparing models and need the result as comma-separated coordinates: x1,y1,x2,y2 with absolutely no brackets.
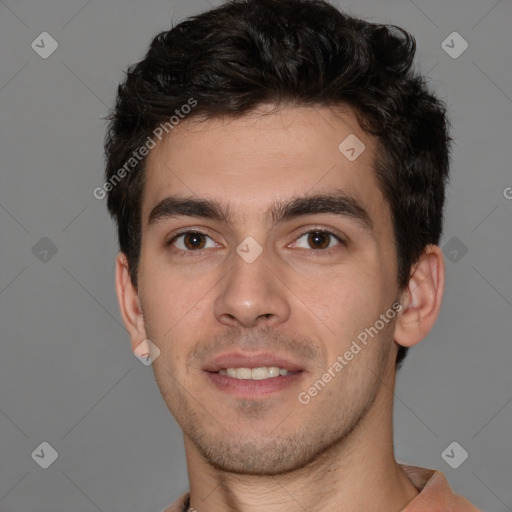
214,244,291,327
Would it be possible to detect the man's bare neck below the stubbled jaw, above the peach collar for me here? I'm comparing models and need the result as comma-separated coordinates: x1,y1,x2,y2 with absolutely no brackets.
185,376,418,512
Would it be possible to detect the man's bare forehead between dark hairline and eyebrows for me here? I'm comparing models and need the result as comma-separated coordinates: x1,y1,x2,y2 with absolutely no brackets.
142,107,387,225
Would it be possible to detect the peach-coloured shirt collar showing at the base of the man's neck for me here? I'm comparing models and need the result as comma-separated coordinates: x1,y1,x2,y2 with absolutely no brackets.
163,464,480,512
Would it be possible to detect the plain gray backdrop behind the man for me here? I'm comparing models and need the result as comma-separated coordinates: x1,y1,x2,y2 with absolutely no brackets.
0,0,512,512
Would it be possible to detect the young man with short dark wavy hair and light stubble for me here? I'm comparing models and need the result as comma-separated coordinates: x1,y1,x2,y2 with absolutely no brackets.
105,0,476,512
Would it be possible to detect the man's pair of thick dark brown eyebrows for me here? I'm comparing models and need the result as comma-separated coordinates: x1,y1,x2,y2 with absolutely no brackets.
148,192,374,234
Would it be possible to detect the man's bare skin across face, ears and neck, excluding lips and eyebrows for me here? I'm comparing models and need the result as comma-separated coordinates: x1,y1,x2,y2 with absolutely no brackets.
116,106,444,512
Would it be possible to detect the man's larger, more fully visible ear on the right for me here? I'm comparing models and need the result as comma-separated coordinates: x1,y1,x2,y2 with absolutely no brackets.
394,245,445,347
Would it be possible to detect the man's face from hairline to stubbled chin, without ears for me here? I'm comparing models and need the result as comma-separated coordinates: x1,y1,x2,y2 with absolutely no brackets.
133,107,399,474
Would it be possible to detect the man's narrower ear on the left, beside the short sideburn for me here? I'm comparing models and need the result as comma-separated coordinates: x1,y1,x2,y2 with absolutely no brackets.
116,252,146,351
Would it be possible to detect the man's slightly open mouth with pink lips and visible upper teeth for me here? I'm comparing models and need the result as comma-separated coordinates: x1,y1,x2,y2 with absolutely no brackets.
203,352,305,398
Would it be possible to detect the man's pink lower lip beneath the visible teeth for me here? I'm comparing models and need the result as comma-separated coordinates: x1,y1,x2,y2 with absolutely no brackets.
205,372,304,398
